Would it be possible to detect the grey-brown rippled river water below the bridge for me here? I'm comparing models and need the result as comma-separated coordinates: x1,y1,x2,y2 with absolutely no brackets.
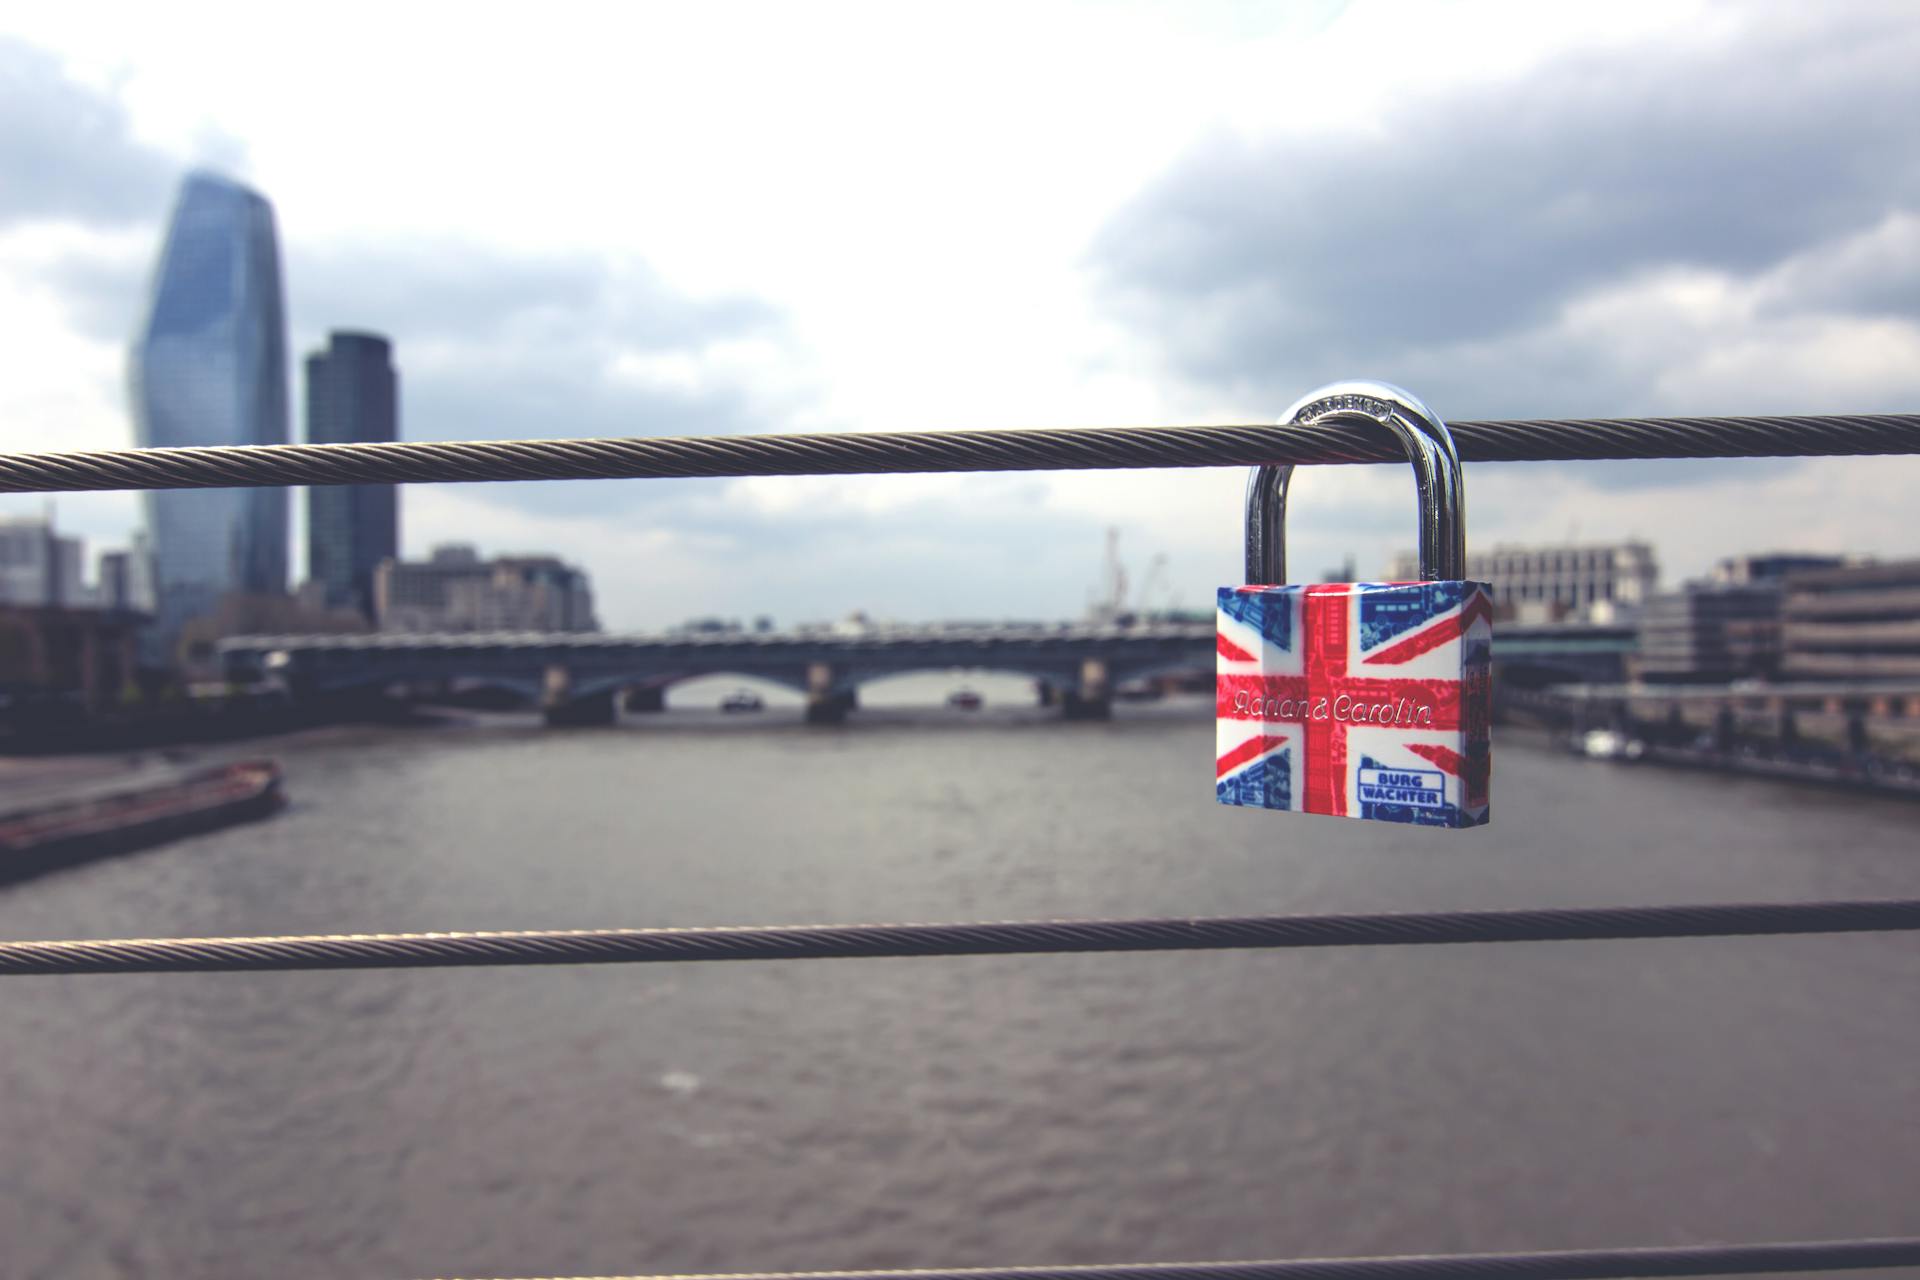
0,685,1920,1280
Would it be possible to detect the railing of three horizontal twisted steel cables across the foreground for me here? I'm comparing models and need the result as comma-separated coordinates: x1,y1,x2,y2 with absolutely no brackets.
0,415,1920,1280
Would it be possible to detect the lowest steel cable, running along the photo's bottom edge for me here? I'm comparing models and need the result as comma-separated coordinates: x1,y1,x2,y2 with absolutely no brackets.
428,1236,1920,1280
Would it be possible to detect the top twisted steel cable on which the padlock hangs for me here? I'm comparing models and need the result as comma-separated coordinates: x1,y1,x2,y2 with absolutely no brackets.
0,413,1920,493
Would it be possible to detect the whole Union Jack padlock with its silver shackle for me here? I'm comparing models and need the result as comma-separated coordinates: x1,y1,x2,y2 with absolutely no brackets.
1213,382,1494,827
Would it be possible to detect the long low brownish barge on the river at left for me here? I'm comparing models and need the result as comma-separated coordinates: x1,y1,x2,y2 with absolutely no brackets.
0,760,286,881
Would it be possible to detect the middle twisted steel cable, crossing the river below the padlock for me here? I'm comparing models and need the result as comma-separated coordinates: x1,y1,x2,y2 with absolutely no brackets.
0,900,1920,977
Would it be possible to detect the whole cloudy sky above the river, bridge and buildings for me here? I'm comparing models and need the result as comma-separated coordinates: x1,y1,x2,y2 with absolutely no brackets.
0,0,1920,628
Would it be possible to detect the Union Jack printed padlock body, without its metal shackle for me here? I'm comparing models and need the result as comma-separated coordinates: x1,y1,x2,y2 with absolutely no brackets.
1213,581,1494,827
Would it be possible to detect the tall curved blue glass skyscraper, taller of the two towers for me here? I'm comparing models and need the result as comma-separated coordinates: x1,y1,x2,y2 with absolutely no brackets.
132,173,288,654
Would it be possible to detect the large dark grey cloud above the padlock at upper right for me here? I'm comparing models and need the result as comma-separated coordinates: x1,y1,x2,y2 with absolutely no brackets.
1092,6,1920,416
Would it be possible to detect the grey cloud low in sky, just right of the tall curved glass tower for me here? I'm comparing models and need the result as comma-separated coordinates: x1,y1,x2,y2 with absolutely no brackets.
288,244,787,518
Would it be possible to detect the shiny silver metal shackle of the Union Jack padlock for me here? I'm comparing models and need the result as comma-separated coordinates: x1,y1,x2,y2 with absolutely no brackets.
1246,382,1467,587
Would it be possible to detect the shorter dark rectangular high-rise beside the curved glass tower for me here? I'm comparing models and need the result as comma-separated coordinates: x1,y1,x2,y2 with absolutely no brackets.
307,332,399,620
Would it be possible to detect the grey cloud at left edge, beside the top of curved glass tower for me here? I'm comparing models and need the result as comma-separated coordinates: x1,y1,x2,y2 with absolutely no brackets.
0,40,179,226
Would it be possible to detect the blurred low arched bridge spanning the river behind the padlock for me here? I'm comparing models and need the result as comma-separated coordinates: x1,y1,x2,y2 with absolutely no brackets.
221,622,1213,725
